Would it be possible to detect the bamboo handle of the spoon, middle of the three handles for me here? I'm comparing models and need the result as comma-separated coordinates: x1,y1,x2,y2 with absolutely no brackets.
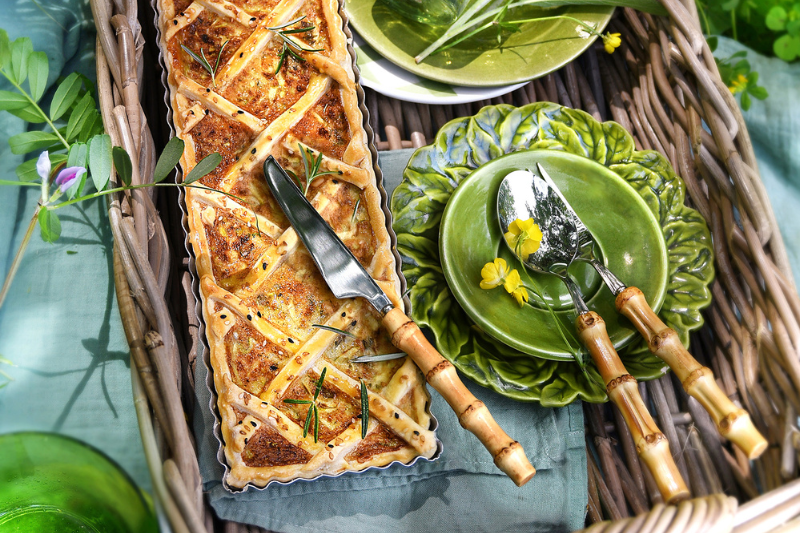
575,311,689,504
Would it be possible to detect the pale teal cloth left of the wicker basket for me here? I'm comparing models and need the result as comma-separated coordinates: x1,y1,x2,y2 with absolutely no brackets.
0,0,150,489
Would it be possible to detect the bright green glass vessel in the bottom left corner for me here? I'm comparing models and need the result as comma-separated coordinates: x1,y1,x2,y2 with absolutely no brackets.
0,432,158,533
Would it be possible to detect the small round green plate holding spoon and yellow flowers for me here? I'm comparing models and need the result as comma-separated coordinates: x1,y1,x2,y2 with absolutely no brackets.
439,150,667,361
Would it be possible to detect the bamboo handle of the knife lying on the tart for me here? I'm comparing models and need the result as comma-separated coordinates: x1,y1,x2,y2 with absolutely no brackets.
383,309,536,487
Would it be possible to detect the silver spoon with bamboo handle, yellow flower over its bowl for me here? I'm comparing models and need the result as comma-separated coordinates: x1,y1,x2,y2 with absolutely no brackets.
497,171,689,503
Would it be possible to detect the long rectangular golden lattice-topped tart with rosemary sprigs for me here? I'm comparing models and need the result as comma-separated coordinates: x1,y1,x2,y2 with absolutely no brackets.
158,0,437,487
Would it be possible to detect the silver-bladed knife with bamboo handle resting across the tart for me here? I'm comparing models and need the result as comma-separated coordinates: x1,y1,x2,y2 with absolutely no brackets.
264,156,536,486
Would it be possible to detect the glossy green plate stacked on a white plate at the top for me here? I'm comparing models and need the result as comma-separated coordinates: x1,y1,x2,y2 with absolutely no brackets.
345,0,614,87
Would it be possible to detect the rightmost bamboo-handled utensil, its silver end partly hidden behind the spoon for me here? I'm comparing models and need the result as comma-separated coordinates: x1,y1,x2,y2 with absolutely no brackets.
537,163,767,459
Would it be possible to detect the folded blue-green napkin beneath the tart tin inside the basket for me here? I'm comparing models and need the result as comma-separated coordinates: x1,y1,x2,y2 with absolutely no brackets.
194,150,587,533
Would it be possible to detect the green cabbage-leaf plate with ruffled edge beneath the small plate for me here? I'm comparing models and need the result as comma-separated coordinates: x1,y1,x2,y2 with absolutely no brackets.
391,102,714,407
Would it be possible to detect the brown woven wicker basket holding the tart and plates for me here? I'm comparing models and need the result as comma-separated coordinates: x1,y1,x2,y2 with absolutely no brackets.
87,0,800,533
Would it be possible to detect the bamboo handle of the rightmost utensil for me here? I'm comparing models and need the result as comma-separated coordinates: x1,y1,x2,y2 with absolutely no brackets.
616,287,767,459
